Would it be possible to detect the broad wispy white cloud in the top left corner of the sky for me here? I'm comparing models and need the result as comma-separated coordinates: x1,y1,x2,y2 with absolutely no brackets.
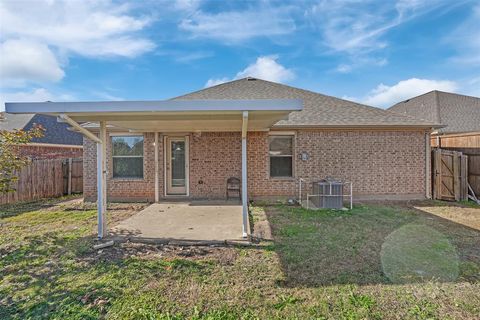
0,0,154,57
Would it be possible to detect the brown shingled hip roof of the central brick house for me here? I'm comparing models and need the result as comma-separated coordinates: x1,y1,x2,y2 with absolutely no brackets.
174,78,433,128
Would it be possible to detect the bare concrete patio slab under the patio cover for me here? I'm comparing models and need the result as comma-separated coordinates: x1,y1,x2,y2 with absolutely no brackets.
110,201,243,244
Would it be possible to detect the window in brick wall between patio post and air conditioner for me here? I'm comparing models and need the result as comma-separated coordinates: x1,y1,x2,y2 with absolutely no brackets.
269,136,293,177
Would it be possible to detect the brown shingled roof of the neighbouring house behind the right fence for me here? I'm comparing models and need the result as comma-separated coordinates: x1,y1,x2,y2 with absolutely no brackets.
388,90,480,133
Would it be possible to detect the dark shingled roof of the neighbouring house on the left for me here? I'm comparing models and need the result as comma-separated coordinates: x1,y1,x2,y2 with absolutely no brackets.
0,112,83,145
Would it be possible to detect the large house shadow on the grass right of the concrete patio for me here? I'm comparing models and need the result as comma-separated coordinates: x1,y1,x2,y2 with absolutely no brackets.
263,200,480,287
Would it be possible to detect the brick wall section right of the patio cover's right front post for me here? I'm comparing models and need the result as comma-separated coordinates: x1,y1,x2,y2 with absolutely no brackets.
248,130,425,198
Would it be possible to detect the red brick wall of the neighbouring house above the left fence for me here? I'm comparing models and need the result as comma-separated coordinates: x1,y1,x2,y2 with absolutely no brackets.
18,144,83,159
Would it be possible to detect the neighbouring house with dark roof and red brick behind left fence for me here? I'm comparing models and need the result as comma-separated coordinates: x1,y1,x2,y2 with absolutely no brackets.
0,112,83,159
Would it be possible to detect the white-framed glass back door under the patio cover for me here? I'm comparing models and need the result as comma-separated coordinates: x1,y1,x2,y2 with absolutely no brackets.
165,137,188,195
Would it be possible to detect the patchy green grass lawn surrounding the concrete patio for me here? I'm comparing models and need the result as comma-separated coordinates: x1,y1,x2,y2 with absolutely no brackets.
0,202,480,319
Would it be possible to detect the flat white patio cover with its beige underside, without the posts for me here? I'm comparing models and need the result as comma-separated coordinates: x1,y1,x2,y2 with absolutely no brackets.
6,99,302,132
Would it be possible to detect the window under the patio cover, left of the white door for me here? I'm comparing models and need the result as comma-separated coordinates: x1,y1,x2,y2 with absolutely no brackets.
112,136,143,178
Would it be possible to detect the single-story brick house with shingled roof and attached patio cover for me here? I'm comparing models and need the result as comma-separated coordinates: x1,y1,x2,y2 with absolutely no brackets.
7,78,434,238
